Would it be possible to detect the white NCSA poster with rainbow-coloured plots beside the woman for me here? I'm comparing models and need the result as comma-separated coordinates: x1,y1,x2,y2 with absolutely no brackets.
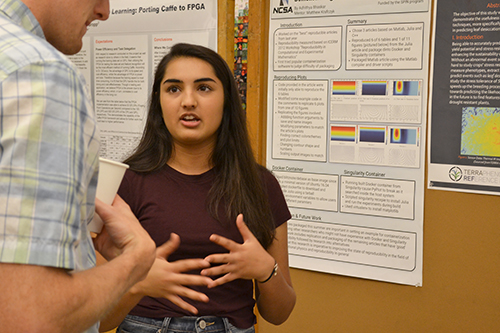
266,0,431,286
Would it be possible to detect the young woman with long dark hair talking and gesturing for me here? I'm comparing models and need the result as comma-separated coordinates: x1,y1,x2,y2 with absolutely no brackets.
102,44,296,333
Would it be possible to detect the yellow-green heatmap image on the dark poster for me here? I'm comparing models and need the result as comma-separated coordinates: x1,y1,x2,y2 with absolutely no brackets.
460,107,500,157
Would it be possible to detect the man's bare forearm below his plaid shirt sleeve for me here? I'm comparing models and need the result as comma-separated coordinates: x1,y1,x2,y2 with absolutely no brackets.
0,250,150,333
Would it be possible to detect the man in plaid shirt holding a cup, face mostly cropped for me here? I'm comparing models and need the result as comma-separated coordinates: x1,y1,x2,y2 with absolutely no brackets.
0,0,155,333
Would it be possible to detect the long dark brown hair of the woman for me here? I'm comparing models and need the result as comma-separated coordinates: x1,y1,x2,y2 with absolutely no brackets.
125,43,275,248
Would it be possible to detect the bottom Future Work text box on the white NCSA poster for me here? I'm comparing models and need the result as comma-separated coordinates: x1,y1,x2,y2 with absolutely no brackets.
288,219,417,272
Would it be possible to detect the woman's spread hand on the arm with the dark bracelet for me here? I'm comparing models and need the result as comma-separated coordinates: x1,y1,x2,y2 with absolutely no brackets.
201,214,275,288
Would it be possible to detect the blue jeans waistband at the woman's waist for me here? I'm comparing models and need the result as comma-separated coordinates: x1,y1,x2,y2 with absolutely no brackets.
116,315,255,333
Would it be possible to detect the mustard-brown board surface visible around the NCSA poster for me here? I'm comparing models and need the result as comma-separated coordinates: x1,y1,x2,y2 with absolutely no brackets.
241,0,500,333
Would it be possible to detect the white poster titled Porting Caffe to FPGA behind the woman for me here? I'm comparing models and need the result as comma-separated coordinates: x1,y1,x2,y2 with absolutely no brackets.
70,0,217,161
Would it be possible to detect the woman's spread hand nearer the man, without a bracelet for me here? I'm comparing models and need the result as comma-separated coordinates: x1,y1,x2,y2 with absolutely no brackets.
130,233,213,314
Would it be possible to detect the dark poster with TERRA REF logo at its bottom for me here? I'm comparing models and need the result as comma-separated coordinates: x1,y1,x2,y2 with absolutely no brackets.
428,0,500,195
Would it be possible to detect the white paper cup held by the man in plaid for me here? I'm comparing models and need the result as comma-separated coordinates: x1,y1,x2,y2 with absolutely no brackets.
88,157,128,233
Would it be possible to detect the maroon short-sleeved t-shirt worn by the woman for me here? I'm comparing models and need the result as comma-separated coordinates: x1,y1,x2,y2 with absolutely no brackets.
118,165,291,328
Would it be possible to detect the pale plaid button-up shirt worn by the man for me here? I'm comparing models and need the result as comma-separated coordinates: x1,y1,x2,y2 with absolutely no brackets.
0,0,99,278
